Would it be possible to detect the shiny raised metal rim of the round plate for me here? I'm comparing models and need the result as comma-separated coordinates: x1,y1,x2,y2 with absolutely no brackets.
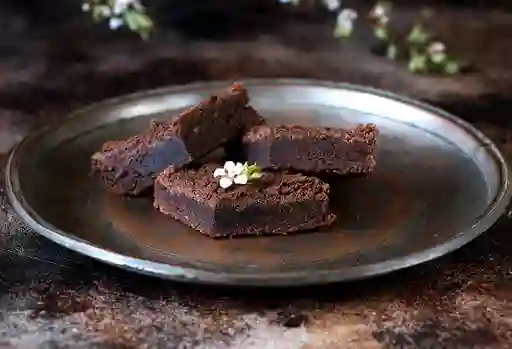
4,78,512,287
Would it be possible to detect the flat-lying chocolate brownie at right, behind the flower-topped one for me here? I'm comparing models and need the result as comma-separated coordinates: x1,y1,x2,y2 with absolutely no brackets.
243,124,378,174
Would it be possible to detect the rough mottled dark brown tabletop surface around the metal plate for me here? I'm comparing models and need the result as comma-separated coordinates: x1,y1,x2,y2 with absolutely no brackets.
0,3,512,349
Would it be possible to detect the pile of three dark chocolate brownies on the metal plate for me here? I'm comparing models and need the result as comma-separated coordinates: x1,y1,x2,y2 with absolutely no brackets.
92,84,377,238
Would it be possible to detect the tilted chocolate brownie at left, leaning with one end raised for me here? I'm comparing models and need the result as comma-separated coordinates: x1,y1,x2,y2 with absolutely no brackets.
92,84,262,195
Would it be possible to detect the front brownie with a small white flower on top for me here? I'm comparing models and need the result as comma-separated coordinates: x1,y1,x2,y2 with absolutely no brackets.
154,164,336,238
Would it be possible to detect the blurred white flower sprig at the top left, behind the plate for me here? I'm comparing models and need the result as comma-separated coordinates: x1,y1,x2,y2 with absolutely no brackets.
82,0,153,39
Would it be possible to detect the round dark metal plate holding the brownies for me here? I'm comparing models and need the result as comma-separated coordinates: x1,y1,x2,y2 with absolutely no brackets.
6,80,511,286
